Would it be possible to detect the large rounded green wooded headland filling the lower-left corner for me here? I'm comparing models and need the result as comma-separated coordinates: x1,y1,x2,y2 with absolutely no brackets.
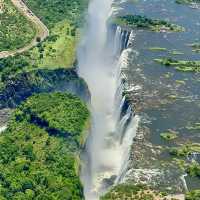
0,93,89,200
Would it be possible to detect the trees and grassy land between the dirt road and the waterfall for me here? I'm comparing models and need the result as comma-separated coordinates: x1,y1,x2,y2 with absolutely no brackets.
22,0,88,68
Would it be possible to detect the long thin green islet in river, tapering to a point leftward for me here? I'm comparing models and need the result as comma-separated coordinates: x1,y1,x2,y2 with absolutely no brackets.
154,58,200,72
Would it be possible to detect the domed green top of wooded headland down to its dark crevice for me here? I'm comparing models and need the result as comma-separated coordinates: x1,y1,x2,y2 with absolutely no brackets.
15,93,89,146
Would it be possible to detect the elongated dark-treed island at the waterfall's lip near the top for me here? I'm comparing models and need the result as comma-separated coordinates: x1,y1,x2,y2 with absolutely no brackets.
113,15,184,32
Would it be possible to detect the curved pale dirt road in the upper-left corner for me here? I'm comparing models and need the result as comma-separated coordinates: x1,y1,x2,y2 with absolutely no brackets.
0,0,49,58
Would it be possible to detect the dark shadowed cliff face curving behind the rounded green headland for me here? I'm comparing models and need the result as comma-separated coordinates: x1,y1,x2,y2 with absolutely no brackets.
0,69,90,109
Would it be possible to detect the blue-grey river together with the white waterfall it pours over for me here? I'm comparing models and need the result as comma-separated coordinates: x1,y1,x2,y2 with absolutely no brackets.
78,0,200,200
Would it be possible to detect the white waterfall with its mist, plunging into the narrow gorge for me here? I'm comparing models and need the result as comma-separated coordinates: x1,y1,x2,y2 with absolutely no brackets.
78,0,139,200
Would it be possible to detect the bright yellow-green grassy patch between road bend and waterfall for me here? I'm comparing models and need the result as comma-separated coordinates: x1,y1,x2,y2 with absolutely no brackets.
31,20,78,68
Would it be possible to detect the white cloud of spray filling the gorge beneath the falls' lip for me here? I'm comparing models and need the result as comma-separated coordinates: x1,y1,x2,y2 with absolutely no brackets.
78,0,139,200
